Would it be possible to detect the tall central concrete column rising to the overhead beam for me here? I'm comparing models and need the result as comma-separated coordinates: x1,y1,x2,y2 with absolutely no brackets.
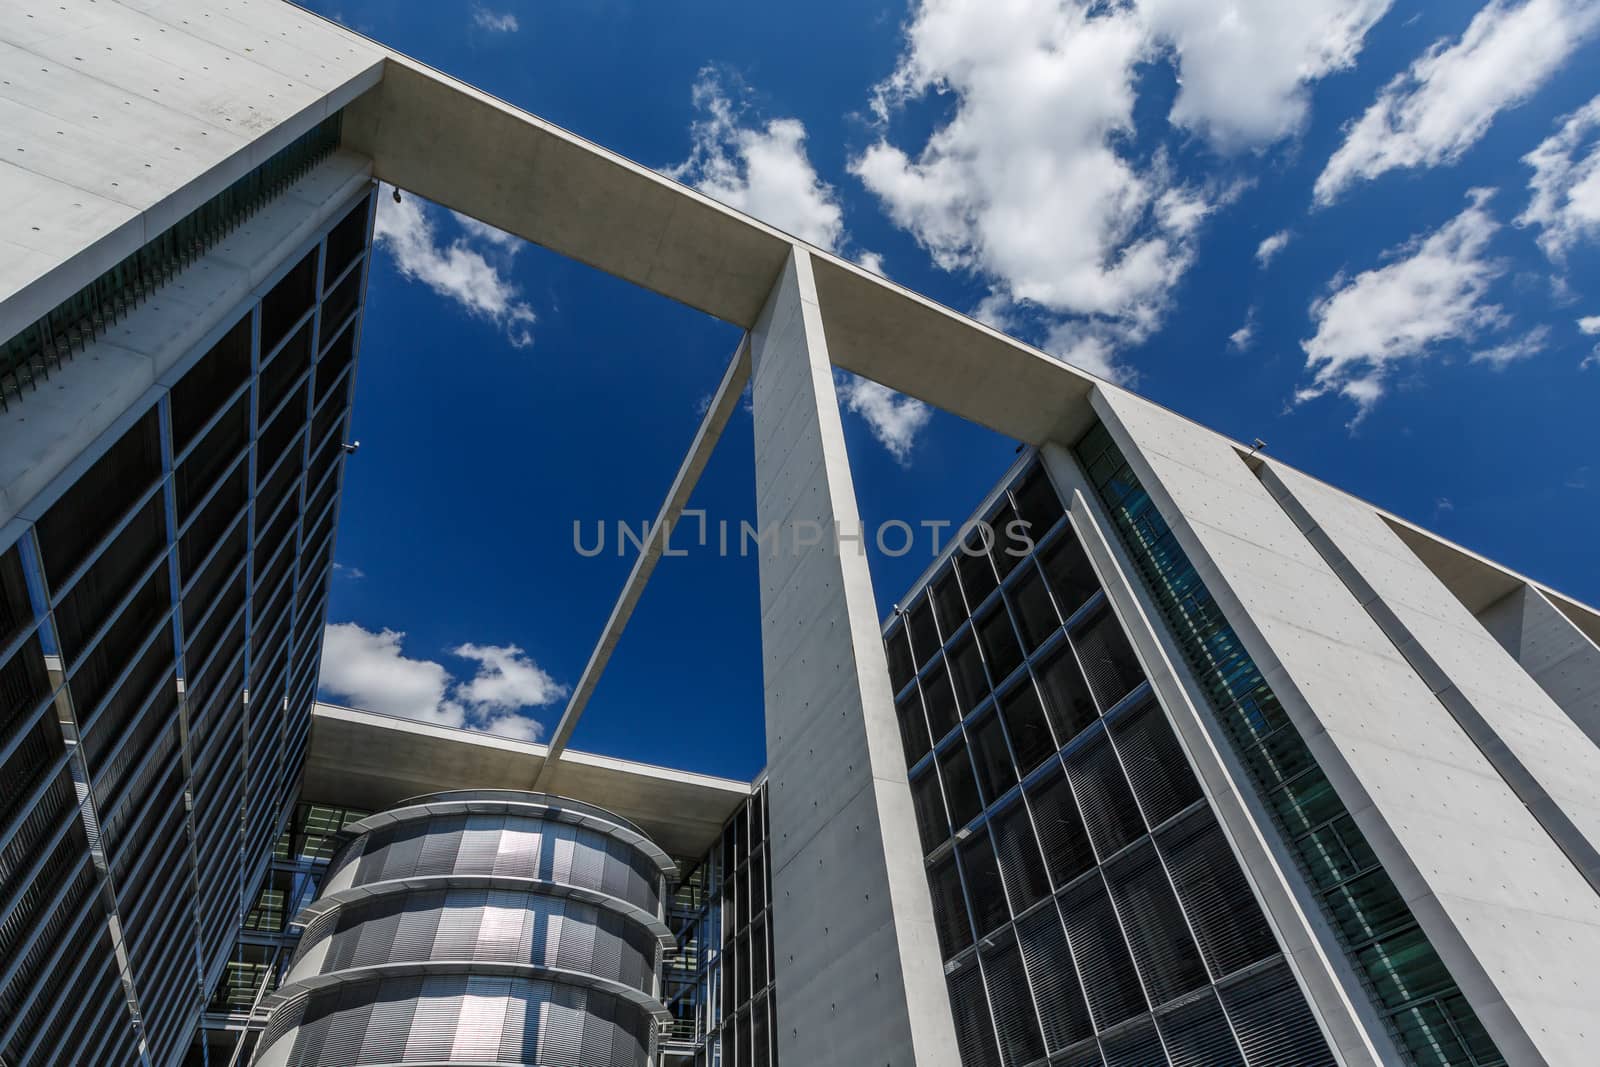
750,246,960,1067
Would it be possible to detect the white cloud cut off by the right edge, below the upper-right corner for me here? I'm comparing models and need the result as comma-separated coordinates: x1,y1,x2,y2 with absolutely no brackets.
1517,96,1600,262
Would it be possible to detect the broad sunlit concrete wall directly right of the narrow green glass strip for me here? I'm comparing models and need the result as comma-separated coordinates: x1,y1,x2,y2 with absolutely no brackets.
1093,390,1600,1065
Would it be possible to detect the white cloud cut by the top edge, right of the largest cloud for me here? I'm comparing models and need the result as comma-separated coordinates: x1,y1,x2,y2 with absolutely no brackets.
1139,0,1390,149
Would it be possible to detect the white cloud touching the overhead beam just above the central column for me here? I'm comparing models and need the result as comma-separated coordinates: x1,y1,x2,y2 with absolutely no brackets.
664,67,845,251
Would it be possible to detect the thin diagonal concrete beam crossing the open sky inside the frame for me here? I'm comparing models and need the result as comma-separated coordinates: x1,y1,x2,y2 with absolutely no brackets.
533,334,750,789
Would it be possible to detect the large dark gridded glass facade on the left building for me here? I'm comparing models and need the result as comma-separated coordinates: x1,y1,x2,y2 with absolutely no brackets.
0,182,371,1067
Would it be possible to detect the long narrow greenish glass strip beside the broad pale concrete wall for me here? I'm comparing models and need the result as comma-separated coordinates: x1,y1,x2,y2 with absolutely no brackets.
1077,426,1506,1067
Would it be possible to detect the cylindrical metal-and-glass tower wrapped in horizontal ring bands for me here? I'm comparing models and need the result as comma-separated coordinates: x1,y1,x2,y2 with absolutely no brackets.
254,790,677,1067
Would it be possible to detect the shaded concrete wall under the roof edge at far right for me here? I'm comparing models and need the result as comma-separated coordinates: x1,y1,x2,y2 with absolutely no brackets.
1477,585,1600,744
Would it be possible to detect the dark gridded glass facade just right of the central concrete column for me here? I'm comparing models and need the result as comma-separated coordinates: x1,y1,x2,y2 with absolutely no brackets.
885,461,1334,1067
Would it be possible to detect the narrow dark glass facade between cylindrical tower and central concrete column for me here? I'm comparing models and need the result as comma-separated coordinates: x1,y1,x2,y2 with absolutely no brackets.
662,782,778,1067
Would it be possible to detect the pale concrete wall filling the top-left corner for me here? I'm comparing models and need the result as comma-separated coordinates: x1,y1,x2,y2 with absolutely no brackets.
0,0,384,329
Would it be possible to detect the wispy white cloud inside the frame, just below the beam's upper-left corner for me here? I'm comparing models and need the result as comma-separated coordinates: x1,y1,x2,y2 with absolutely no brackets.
373,182,536,349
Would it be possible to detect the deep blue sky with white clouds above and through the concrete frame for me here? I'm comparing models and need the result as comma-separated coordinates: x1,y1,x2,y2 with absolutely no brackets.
312,0,1600,777
